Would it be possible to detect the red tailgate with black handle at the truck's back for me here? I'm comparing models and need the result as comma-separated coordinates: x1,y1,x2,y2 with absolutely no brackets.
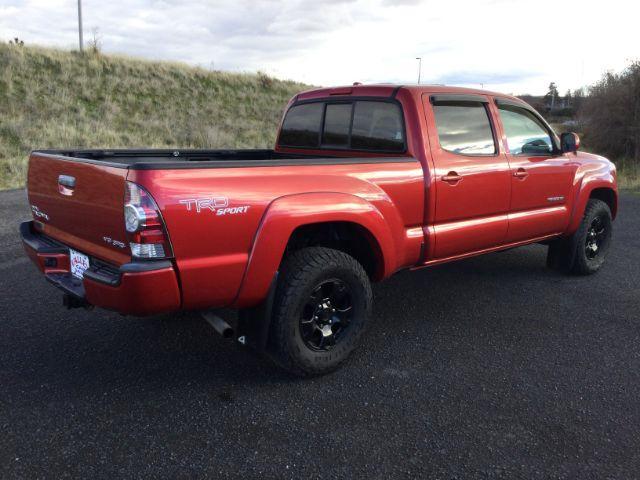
27,152,131,265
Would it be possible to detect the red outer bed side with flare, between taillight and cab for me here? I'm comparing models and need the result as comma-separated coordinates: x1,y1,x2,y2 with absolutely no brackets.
128,161,424,308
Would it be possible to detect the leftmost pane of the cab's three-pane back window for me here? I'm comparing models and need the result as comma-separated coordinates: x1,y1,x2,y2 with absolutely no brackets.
280,103,324,147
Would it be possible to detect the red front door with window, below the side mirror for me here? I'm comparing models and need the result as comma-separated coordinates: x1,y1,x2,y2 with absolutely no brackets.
496,99,577,243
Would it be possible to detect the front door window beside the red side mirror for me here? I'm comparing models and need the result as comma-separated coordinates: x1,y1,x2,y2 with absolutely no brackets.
498,105,553,155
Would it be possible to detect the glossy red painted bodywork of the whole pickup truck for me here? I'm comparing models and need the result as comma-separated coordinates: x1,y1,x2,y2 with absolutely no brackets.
22,85,617,314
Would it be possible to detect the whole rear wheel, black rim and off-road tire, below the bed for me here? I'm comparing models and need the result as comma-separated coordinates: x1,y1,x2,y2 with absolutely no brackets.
270,247,372,376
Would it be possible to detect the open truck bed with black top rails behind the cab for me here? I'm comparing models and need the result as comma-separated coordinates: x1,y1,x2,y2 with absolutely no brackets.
32,149,415,170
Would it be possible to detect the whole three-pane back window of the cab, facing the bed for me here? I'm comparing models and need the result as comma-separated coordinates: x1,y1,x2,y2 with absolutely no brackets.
278,99,406,153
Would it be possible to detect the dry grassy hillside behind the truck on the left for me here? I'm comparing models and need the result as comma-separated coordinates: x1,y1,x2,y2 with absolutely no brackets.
0,44,308,188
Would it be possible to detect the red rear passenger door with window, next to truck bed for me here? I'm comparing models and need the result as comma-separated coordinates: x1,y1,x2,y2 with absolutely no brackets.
423,94,511,259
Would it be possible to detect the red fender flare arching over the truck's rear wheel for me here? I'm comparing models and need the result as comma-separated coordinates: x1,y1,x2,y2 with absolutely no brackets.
233,192,397,308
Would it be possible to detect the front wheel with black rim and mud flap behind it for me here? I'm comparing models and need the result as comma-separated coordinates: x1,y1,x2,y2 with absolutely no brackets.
547,199,613,275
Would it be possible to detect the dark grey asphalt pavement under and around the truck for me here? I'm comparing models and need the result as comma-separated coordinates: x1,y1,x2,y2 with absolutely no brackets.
0,191,640,479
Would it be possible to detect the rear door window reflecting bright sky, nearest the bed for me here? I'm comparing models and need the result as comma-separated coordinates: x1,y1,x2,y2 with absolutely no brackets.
433,102,496,155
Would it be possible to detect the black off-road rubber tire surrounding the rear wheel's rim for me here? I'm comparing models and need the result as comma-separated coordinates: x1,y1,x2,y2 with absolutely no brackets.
269,247,372,376
